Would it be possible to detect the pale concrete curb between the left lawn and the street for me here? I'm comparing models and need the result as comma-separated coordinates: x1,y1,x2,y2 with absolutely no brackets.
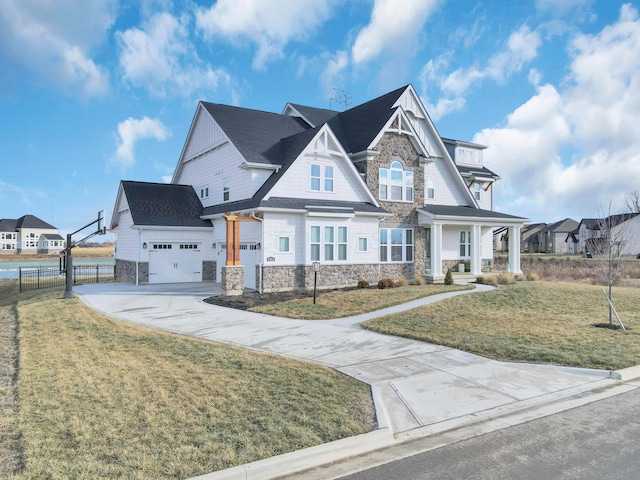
189,428,397,480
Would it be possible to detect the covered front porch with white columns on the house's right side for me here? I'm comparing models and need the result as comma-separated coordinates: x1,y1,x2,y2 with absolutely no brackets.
418,205,528,281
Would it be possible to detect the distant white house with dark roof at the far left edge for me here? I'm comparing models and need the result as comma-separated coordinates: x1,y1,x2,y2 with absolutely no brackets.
0,215,65,254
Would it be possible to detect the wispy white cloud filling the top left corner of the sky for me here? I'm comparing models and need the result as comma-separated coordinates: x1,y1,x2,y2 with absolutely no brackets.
0,0,117,97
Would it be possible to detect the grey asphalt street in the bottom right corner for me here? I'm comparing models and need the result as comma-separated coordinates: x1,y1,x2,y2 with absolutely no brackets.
342,390,640,480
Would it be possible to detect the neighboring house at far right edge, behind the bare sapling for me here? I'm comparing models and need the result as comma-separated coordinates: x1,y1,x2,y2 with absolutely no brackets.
577,213,640,256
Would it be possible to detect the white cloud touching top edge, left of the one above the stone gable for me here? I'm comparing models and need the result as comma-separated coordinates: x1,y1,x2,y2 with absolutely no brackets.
196,0,336,70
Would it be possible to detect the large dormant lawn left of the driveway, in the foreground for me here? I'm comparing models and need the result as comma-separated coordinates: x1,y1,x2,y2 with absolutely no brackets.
0,282,375,479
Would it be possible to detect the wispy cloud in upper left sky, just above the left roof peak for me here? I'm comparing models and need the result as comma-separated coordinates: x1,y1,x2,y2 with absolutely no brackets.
116,12,231,97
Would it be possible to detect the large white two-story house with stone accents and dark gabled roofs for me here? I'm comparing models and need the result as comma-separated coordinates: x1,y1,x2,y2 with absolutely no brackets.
111,85,526,293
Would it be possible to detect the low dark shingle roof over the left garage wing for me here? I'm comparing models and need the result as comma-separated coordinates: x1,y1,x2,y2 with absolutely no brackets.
122,180,211,227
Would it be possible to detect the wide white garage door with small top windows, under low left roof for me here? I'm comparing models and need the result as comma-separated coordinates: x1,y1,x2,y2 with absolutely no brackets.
149,243,202,283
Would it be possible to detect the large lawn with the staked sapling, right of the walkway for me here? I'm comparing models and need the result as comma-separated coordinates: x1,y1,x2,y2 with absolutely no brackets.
365,282,640,370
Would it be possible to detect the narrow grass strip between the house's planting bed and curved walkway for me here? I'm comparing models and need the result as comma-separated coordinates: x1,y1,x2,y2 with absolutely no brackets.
249,285,473,320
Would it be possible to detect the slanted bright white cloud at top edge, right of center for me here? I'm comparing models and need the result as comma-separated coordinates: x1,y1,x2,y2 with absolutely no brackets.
351,0,439,65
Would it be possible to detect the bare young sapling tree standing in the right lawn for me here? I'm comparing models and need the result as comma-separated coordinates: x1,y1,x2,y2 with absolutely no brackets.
589,202,637,326
